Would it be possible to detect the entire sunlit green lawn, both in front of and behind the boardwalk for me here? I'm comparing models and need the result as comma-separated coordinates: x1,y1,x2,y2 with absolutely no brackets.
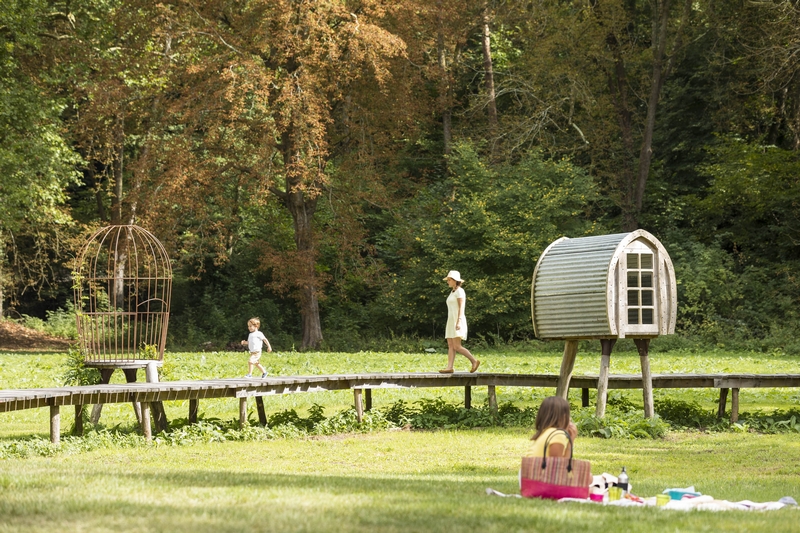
0,344,800,533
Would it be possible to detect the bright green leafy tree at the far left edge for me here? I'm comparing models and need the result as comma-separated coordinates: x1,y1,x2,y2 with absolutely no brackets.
0,0,79,317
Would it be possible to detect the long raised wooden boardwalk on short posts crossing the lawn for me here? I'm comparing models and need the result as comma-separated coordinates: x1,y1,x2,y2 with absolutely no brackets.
0,372,800,442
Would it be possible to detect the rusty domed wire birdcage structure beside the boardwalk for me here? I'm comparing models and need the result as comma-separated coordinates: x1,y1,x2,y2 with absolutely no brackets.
73,225,172,366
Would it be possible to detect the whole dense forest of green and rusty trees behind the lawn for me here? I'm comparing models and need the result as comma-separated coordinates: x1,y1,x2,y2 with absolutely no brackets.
0,0,800,353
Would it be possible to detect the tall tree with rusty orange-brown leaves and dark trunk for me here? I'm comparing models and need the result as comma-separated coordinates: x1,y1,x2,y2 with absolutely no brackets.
148,0,412,348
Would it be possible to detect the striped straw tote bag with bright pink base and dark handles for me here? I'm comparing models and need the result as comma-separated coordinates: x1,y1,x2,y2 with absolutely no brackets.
520,429,592,500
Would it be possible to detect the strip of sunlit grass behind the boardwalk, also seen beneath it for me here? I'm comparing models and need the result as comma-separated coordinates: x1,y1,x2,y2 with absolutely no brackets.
0,348,800,438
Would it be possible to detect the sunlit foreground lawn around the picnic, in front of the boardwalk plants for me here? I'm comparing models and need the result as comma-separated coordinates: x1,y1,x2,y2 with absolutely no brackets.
0,429,800,533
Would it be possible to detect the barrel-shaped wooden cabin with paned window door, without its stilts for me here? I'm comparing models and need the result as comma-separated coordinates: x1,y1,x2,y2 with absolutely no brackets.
531,229,677,340
